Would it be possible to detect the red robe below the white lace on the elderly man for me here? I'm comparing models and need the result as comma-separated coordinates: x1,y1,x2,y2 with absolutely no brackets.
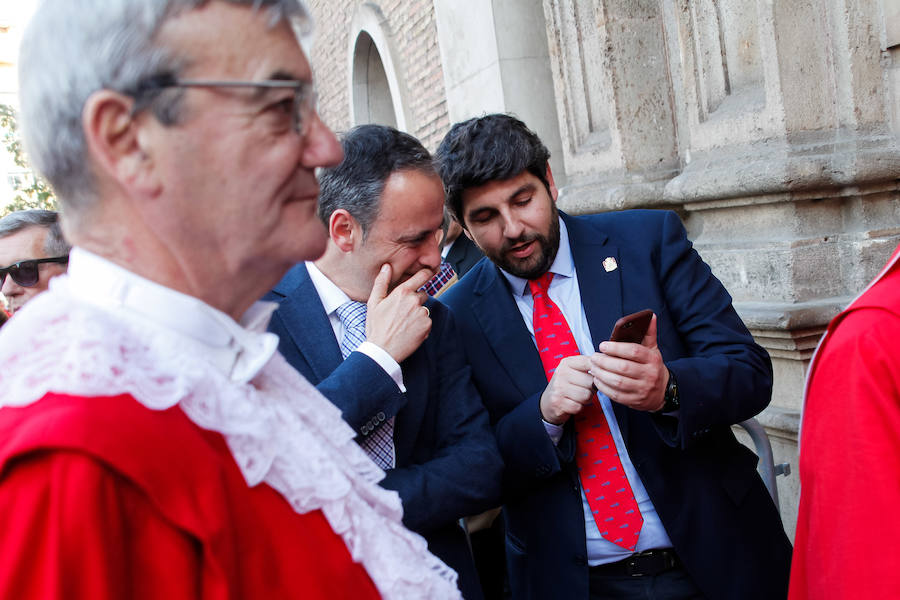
0,394,379,600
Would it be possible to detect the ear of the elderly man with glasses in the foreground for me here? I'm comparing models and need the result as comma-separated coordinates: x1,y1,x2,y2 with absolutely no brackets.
81,90,160,195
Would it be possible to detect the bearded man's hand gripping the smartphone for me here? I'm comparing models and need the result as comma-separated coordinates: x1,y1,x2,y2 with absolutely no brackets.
591,315,669,411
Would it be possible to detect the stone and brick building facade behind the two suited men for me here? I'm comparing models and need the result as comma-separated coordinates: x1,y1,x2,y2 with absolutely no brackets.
310,0,900,535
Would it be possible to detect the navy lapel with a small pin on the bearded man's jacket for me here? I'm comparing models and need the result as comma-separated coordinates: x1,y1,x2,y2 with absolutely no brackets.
563,214,628,443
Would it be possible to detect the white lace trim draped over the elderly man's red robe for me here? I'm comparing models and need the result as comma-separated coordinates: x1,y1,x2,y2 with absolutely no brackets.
0,278,460,600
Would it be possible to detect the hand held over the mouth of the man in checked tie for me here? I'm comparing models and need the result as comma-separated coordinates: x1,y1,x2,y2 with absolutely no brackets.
366,264,433,363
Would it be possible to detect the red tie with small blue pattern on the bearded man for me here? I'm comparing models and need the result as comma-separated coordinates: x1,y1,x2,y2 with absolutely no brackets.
528,271,644,552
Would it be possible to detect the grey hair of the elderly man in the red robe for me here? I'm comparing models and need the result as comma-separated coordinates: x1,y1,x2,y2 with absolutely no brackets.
19,0,312,212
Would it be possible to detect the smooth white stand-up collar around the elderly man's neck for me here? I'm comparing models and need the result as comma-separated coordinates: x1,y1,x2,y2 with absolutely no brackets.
67,247,278,383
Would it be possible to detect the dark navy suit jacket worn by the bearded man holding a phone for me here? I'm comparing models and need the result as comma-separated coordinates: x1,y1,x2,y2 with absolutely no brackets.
441,211,791,600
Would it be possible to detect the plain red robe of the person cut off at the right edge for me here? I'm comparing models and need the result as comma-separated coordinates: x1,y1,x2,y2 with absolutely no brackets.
790,241,900,600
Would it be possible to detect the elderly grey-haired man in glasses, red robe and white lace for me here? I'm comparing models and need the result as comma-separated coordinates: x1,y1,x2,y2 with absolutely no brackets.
0,0,458,600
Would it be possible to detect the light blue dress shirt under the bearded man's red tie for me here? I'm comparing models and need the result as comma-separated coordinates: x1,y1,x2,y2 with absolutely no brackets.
501,219,672,566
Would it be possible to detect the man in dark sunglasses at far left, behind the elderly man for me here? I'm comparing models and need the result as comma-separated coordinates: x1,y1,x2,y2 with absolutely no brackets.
0,210,69,313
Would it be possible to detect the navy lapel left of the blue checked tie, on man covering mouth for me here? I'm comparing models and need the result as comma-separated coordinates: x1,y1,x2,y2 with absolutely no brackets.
276,264,343,384
